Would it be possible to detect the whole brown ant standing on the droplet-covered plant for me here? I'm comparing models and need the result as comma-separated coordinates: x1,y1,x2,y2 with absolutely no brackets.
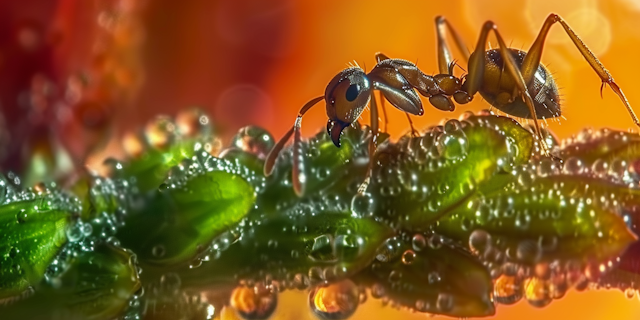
264,14,640,196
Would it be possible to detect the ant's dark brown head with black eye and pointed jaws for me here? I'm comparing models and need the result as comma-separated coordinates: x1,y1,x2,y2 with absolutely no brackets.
324,67,373,147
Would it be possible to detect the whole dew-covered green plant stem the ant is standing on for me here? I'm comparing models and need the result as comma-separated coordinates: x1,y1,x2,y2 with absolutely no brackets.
0,111,640,319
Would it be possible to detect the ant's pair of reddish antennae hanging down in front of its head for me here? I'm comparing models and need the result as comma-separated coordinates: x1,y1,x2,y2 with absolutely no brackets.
264,96,324,196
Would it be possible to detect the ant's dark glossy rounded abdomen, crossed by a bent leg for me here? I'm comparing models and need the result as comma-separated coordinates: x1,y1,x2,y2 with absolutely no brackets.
479,48,561,119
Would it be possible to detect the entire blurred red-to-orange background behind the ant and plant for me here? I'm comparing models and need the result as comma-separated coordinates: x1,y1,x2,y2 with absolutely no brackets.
0,0,640,320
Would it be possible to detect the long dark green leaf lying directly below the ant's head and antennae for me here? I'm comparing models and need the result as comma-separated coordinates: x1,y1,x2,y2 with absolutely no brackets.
178,211,393,289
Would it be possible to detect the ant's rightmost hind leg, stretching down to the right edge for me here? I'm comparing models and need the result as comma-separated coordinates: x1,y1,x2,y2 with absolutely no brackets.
520,13,640,127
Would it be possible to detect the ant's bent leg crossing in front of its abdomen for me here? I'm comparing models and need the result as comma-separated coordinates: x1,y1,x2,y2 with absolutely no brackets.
468,21,550,155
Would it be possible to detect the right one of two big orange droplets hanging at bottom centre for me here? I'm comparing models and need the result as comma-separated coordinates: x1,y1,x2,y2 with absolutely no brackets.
309,279,360,320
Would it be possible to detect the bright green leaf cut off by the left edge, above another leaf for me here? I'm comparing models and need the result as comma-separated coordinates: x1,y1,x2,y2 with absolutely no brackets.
0,192,72,298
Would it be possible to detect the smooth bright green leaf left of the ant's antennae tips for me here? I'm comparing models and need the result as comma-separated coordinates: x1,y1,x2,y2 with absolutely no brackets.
117,171,254,267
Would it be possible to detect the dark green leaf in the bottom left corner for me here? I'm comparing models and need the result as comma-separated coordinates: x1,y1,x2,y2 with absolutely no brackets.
2,244,140,320
